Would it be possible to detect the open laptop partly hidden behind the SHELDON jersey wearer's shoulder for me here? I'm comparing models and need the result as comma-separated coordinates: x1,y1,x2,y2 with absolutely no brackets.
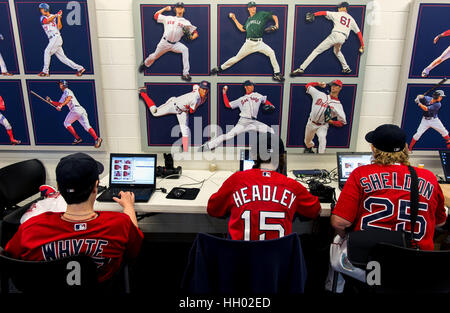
336,152,372,190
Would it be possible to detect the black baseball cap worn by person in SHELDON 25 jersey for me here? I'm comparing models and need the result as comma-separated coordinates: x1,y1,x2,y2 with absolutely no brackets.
366,124,406,152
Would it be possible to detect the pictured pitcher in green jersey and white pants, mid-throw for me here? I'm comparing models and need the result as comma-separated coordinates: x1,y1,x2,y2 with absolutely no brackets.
211,1,284,82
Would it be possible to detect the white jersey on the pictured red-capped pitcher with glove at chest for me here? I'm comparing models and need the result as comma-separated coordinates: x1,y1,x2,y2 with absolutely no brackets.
306,86,347,124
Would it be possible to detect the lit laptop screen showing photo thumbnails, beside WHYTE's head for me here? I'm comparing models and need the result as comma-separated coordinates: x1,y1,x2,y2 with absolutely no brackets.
110,154,156,185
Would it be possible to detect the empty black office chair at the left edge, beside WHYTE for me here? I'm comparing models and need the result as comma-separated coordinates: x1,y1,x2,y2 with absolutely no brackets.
0,159,46,247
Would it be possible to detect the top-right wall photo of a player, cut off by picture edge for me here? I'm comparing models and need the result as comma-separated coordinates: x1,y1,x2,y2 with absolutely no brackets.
409,1,450,78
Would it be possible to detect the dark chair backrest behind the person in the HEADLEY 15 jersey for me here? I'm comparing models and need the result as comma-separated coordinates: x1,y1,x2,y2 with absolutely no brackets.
182,233,306,294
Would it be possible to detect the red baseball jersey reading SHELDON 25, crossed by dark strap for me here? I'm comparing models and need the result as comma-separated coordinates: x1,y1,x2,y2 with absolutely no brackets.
332,164,447,250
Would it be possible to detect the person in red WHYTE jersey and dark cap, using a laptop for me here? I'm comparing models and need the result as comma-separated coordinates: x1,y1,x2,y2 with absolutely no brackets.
5,153,143,282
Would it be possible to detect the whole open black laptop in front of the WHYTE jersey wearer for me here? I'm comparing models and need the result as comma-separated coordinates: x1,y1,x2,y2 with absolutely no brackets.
97,153,156,202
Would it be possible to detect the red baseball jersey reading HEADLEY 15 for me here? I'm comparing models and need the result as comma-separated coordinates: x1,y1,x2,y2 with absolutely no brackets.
208,169,320,240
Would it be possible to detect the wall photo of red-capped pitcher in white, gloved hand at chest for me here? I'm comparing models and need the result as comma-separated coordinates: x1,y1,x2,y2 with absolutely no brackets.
286,79,357,153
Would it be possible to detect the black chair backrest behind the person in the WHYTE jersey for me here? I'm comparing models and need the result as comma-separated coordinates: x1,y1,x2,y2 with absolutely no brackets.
0,248,98,293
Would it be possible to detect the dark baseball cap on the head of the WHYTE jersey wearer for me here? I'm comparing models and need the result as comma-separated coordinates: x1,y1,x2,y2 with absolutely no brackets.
56,152,104,194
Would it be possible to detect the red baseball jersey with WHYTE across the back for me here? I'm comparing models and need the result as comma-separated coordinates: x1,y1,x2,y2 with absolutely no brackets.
5,212,144,282
